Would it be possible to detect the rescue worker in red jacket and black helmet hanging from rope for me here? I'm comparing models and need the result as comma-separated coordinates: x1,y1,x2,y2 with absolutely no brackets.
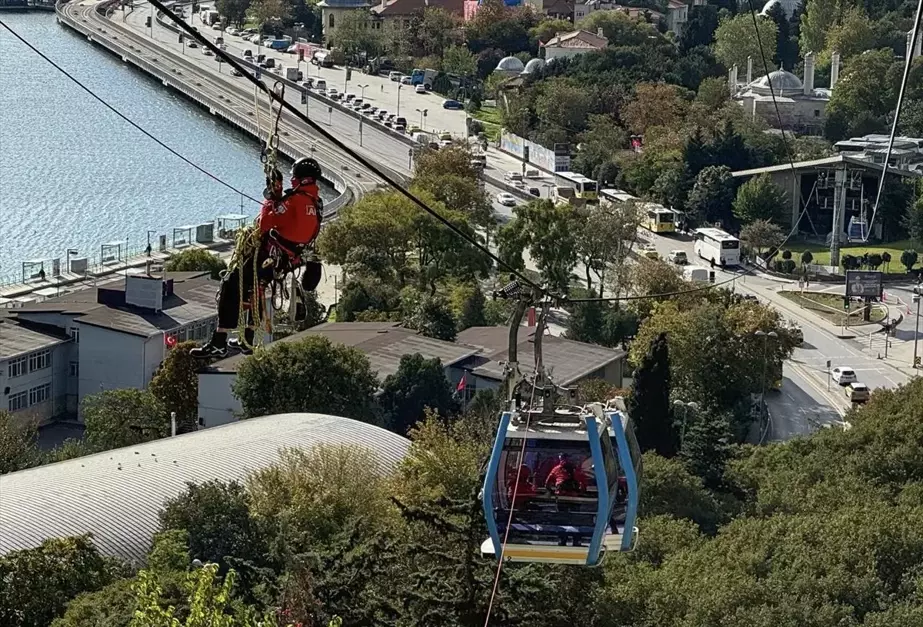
191,158,323,358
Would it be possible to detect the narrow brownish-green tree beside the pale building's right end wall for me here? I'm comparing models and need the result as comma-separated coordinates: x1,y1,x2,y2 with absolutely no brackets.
148,342,202,433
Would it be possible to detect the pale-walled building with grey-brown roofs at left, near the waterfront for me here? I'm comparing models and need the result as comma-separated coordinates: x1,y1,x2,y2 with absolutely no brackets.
0,272,217,421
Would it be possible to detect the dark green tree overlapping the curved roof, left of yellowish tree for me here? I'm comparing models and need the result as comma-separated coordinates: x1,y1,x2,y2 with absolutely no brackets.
159,481,268,568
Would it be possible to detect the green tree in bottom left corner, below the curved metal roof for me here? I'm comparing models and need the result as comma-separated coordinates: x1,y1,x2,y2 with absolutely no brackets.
0,535,124,627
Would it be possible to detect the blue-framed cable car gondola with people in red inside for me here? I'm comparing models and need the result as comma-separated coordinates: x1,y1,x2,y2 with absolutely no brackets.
481,398,641,566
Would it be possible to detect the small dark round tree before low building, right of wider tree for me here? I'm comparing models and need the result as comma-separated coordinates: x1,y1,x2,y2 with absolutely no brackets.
379,353,458,435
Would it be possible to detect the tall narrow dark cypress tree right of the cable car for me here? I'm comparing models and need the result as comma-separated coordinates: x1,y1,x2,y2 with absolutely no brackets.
628,333,678,457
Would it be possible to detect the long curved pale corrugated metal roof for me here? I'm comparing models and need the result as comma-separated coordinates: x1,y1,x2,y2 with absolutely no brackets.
0,413,410,561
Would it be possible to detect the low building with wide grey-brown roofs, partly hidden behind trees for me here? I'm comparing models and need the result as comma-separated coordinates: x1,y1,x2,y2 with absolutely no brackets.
199,322,626,427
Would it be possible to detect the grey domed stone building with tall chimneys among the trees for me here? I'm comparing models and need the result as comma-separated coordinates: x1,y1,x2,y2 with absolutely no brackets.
728,52,840,135
